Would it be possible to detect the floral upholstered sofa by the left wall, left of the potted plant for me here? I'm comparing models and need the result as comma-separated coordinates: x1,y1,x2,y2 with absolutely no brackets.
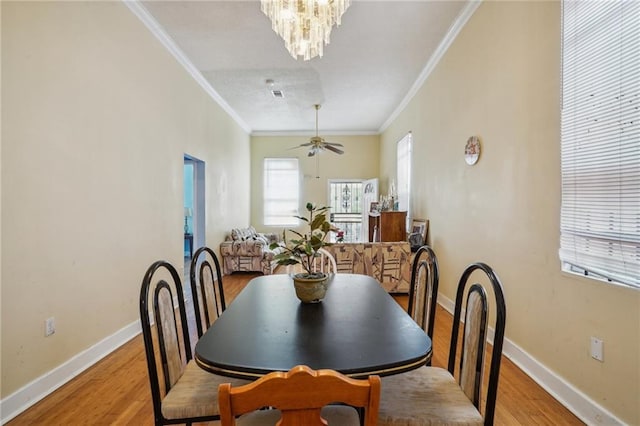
220,226,281,275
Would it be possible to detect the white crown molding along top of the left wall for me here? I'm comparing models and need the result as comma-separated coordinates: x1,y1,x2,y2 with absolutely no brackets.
122,0,251,134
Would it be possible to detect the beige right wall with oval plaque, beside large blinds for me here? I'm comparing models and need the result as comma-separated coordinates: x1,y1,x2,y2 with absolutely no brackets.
381,2,640,424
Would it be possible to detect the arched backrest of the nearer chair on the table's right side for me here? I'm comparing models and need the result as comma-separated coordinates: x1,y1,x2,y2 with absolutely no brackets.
448,263,507,425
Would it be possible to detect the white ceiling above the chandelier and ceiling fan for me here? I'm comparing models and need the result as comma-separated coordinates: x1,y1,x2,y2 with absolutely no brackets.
141,0,467,134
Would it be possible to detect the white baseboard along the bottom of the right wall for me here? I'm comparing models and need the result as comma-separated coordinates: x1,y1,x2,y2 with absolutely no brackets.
436,294,624,426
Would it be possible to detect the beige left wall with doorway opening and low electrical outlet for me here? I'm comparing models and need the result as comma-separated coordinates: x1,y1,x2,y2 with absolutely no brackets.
1,2,250,398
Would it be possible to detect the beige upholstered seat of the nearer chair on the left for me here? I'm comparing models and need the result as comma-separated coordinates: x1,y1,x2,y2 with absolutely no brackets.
162,360,249,419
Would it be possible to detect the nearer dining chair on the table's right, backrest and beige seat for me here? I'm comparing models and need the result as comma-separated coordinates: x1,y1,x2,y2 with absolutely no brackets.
379,263,506,426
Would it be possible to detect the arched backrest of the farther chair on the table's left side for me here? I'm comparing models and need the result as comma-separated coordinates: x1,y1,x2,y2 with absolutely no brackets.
189,247,227,337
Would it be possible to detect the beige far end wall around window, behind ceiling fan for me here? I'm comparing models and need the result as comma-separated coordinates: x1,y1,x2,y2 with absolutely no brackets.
251,135,380,232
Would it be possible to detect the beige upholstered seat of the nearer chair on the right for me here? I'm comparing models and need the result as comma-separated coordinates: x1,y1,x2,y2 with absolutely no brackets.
378,367,484,426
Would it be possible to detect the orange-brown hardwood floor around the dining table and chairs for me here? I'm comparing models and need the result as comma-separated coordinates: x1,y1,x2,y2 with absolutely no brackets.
7,273,583,426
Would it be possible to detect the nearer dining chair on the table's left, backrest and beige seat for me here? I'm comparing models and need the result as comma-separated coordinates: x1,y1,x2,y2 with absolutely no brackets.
140,260,248,425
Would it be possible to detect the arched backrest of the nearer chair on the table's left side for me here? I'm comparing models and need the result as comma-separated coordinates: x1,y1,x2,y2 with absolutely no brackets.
140,260,192,421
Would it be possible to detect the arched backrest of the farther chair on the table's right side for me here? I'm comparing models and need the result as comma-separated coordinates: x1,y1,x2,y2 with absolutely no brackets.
407,246,440,338
